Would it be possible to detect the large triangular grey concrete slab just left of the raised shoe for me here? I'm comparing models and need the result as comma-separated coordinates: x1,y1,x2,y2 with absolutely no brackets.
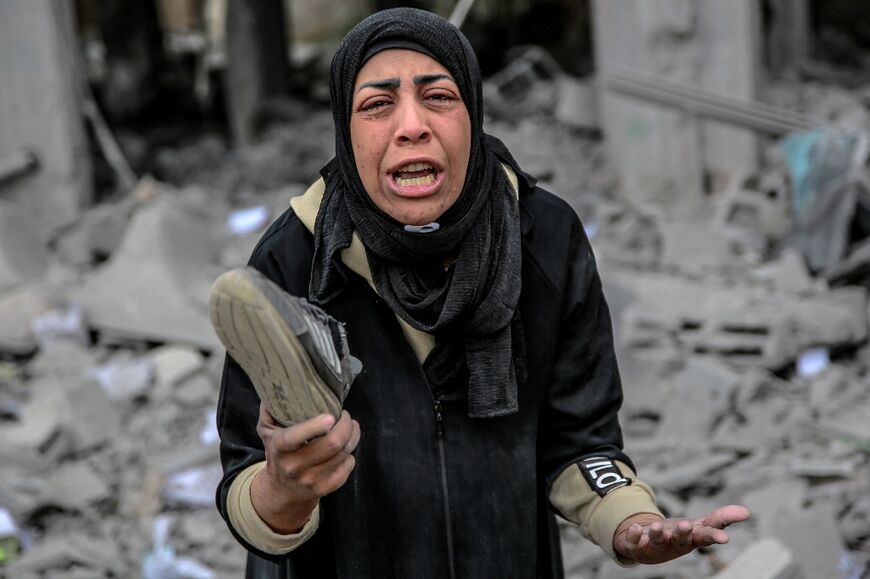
74,195,218,350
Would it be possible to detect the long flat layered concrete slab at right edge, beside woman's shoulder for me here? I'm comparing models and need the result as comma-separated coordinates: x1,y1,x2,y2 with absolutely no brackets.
619,273,867,369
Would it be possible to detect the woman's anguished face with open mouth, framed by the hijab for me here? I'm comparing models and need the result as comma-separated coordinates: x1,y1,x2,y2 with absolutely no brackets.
350,49,471,225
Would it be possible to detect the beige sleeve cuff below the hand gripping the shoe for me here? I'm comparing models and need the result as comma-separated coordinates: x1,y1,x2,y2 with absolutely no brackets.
227,462,320,555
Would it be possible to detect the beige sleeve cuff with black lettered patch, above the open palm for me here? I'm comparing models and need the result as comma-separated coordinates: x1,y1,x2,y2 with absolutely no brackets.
550,460,664,567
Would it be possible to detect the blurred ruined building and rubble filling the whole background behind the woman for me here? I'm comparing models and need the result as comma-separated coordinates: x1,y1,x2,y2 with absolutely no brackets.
0,0,870,579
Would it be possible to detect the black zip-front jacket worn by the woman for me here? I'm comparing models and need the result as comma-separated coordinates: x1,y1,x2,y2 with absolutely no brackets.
217,187,631,579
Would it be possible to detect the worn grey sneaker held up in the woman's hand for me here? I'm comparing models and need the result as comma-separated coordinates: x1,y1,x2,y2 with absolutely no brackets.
209,267,362,426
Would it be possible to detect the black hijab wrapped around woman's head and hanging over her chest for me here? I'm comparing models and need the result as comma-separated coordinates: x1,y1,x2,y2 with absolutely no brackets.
310,8,534,417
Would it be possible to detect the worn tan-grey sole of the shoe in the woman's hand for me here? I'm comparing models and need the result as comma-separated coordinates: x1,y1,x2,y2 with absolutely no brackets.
209,270,341,426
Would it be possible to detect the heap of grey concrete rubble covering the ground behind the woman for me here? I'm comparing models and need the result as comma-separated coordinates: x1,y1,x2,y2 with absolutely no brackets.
0,48,870,579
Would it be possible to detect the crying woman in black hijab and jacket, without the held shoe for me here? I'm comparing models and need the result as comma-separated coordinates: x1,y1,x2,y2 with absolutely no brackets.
218,8,748,579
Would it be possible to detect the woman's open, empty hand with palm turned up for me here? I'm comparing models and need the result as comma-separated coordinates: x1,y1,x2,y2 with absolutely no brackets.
613,505,749,565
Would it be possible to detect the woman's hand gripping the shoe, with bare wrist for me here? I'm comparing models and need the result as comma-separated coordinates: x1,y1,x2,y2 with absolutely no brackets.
251,404,360,535
